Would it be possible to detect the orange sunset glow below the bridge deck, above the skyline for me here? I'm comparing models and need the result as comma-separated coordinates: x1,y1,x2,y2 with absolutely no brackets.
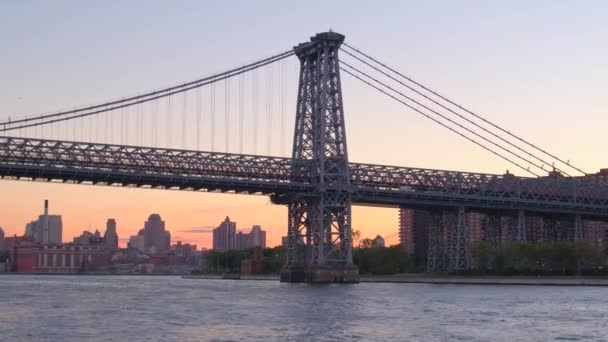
0,181,398,249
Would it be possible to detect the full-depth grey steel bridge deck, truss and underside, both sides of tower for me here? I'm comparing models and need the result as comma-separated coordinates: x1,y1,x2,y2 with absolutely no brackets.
0,137,608,218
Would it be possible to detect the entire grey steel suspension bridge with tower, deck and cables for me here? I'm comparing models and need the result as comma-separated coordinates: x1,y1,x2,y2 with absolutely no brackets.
0,32,608,282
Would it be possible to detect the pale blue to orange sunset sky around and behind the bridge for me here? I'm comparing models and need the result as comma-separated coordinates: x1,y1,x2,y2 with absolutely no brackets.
0,1,608,247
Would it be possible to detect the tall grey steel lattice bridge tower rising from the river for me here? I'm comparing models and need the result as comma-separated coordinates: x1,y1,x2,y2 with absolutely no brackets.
281,32,359,282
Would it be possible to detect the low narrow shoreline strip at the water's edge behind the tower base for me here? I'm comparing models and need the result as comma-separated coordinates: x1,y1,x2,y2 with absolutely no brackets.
182,274,608,286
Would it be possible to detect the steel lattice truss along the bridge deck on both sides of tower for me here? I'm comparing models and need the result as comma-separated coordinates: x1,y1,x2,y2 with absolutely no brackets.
0,137,608,206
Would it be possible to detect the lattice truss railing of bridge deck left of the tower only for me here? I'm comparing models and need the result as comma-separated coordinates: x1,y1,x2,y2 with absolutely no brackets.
0,137,296,183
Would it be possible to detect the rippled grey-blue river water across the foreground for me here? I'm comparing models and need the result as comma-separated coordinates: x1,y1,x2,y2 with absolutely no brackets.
0,275,608,341
